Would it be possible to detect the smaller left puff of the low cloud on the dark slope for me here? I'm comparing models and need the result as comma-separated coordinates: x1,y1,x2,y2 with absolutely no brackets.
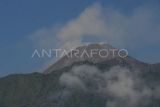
60,65,101,91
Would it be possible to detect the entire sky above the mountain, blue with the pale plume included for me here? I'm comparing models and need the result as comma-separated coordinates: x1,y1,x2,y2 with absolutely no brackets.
0,0,160,76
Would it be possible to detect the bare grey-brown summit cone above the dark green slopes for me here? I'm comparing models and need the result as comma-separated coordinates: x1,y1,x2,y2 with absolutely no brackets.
44,44,148,74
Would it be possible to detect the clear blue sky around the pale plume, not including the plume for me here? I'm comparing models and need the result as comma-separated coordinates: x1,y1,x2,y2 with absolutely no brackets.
0,0,160,76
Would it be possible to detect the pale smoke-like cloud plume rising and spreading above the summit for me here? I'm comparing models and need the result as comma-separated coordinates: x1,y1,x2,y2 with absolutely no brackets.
32,3,160,49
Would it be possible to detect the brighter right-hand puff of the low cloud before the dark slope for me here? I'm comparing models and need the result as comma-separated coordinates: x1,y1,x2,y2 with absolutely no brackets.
105,66,152,107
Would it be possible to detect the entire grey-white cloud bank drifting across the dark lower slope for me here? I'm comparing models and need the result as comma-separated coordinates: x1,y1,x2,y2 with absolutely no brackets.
59,65,160,107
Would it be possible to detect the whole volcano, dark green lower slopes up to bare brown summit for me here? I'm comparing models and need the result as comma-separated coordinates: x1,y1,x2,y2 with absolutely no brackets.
0,44,160,107
